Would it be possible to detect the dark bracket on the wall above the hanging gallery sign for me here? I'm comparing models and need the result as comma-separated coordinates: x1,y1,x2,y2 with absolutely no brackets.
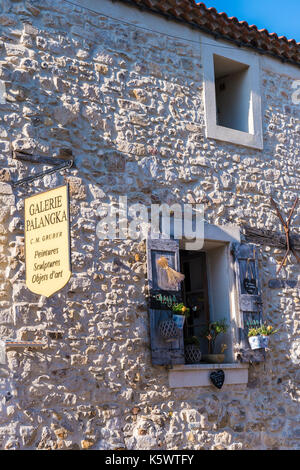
11,151,74,188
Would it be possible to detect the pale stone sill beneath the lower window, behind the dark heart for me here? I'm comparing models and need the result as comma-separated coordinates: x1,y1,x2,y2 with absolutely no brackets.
169,363,249,388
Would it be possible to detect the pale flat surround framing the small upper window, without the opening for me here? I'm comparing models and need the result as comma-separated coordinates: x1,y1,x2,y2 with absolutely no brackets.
202,38,263,150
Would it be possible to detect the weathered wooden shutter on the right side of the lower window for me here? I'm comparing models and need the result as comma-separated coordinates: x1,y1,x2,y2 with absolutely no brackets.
233,243,265,362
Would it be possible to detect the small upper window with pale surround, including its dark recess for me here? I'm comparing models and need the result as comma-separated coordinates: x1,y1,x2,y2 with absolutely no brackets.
203,44,263,149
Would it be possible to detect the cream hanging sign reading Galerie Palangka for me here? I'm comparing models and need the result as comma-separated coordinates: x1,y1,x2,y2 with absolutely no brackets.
24,185,71,297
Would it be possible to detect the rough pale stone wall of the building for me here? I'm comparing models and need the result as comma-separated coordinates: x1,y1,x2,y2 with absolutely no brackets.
0,0,300,449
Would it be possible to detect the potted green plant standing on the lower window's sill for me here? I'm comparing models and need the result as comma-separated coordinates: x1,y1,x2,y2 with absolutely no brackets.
202,319,228,364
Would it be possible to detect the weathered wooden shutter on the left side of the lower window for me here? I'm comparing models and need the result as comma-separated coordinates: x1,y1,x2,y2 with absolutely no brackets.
147,239,185,366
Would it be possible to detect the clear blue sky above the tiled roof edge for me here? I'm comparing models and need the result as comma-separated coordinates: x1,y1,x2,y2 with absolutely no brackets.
196,0,300,42
